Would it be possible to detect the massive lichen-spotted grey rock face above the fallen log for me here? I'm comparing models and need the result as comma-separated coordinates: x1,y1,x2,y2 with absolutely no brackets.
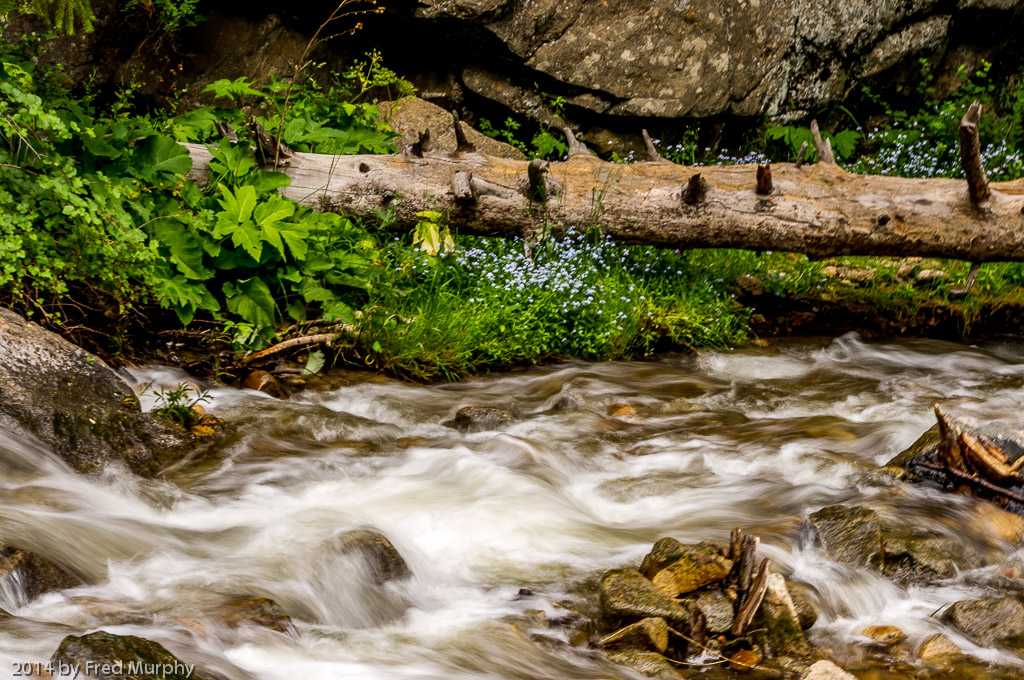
403,0,1022,118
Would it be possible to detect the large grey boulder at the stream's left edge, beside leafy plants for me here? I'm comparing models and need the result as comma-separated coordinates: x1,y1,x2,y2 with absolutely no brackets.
0,308,193,476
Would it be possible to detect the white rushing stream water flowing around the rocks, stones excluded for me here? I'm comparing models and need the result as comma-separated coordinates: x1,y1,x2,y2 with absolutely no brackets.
0,336,1024,680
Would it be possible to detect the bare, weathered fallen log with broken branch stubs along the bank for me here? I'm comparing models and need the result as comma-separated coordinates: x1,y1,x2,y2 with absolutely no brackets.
185,107,1024,263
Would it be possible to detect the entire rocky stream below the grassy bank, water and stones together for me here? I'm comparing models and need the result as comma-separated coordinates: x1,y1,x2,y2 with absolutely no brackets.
0,315,1024,680
